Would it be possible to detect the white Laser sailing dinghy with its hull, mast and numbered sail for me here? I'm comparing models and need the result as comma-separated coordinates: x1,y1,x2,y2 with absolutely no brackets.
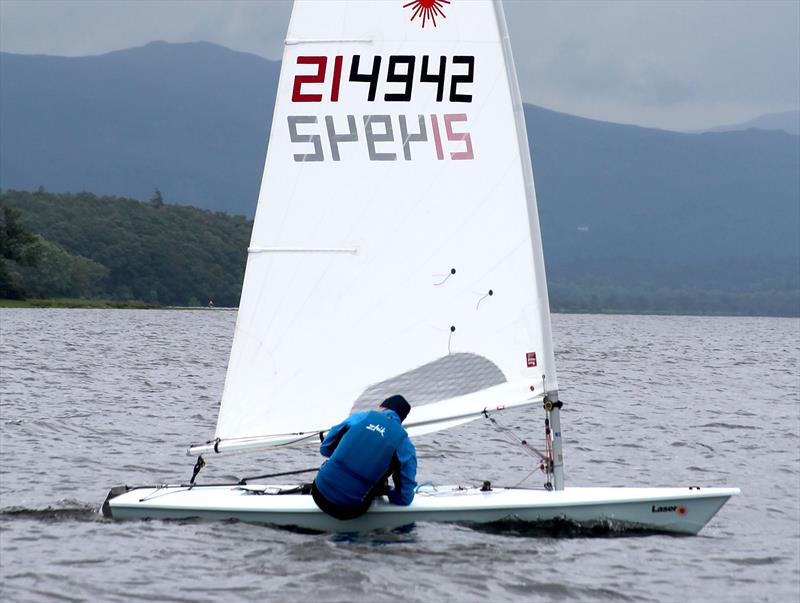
103,0,739,534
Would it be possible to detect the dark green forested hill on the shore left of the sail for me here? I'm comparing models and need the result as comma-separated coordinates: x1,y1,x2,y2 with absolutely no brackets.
0,191,253,307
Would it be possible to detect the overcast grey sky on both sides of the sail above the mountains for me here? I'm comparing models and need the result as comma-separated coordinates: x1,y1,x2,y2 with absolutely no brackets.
0,0,800,130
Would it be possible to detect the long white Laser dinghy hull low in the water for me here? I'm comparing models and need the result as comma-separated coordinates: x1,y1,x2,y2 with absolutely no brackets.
103,485,739,534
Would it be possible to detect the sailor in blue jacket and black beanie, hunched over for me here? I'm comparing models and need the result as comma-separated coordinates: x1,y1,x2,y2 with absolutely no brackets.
311,396,417,519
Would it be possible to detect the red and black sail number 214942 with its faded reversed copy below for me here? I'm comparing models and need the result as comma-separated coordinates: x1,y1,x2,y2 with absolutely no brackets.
287,54,475,161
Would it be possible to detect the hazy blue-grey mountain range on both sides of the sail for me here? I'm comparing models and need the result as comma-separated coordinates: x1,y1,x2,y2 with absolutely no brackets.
0,42,800,316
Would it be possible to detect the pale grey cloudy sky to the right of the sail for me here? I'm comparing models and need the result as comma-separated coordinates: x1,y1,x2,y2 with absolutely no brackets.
506,2,800,128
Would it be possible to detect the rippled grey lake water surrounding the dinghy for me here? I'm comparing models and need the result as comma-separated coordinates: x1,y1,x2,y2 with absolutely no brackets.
0,309,800,603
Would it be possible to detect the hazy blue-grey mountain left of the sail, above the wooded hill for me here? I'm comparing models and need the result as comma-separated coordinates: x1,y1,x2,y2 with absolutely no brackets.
0,42,280,216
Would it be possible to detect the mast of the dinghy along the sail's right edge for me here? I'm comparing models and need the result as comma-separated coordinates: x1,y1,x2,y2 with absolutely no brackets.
494,0,564,490
